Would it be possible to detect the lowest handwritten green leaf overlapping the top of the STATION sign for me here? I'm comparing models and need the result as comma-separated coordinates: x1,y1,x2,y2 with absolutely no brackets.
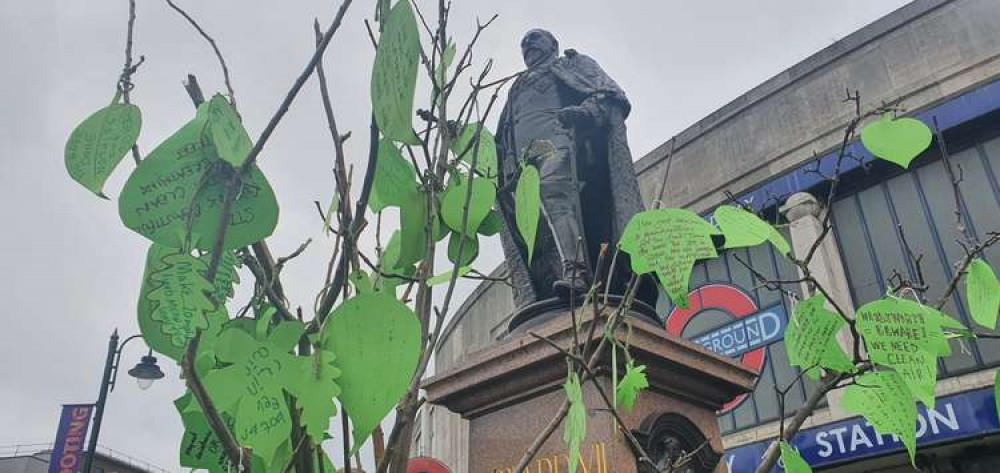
843,371,917,463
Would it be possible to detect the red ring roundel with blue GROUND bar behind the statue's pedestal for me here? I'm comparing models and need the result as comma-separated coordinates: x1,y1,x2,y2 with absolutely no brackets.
666,284,788,412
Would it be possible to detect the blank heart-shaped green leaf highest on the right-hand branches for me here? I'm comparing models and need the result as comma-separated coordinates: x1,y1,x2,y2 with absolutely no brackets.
861,114,933,168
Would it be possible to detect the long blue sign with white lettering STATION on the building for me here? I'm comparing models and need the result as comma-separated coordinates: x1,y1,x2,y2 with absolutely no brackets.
723,388,1000,473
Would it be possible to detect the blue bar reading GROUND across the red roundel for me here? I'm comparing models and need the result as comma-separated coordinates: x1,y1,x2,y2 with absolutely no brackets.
691,304,788,358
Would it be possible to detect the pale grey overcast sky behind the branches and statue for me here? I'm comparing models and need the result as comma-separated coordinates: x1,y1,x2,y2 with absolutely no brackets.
0,0,906,472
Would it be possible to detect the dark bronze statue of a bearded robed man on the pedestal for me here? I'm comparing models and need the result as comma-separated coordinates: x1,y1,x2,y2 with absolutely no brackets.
496,29,656,318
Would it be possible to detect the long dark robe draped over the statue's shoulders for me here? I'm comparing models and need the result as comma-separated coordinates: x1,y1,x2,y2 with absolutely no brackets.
496,50,657,308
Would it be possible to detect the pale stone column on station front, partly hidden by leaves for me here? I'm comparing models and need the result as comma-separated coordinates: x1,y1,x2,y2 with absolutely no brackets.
779,192,854,415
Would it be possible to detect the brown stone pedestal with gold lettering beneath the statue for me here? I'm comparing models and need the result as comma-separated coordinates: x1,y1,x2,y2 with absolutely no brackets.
424,308,756,473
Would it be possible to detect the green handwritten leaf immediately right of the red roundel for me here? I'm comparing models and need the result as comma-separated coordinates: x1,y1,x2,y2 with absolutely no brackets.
785,293,854,379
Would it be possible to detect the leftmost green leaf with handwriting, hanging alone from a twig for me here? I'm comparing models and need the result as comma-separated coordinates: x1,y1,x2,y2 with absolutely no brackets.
64,103,142,197
